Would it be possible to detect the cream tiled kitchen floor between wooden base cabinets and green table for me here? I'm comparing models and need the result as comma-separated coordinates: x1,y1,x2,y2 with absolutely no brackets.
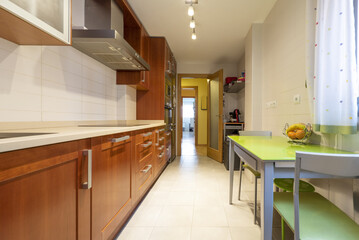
117,156,260,240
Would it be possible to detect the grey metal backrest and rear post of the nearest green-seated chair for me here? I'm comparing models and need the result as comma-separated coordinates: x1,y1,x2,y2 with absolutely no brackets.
293,152,359,240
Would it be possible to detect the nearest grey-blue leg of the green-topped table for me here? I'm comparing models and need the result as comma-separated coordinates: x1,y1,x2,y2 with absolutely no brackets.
261,162,274,240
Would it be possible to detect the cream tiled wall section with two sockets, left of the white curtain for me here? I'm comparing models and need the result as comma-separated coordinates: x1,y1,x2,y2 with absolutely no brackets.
262,0,311,135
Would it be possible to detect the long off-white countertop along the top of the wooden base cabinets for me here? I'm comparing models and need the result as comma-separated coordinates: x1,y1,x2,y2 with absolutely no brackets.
0,120,165,153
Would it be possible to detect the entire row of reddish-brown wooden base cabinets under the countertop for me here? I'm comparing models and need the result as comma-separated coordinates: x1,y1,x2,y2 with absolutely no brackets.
0,128,167,240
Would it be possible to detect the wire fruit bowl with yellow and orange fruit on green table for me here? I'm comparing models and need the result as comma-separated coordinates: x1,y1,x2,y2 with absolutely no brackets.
283,123,312,144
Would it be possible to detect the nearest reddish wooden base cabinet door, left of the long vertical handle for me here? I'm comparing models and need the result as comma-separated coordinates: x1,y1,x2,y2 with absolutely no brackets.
0,140,90,240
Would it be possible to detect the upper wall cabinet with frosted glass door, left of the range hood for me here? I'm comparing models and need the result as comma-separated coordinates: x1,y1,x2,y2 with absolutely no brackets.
0,0,71,45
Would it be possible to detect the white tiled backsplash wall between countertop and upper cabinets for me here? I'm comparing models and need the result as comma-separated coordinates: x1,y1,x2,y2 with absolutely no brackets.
0,38,136,122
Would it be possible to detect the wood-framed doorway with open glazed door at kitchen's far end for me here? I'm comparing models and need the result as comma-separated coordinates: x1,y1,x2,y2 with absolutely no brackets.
177,70,223,162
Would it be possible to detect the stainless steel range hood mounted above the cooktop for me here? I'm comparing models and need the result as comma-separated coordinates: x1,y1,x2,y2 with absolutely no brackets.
72,0,150,71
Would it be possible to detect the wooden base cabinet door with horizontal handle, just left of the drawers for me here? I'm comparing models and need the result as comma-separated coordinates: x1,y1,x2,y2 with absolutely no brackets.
92,133,132,240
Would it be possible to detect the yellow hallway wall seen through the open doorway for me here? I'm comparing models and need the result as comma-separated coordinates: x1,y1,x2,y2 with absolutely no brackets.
181,78,208,145
